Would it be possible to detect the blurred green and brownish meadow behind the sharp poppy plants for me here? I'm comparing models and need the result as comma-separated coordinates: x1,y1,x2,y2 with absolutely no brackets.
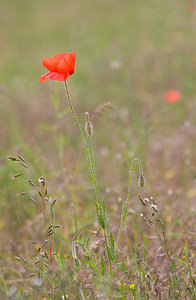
0,0,196,299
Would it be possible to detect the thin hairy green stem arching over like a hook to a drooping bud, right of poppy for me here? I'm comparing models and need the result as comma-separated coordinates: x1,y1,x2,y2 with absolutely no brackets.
115,158,143,252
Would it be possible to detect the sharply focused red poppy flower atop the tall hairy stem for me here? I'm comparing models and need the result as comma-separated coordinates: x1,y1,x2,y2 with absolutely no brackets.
40,52,76,82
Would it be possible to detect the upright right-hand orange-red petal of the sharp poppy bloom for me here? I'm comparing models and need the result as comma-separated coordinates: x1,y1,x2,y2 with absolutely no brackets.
57,52,76,75
